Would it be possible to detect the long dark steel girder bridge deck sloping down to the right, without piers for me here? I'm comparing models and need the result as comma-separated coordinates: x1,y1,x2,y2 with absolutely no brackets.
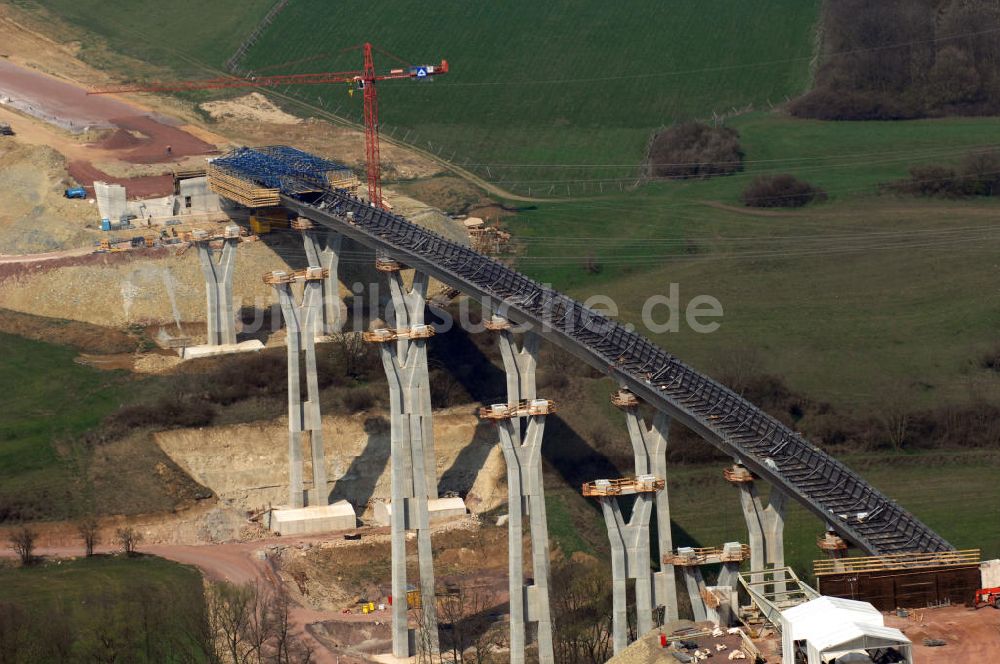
215,150,953,555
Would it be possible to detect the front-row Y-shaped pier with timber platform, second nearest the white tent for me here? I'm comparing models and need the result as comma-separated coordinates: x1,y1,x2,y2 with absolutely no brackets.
598,493,653,655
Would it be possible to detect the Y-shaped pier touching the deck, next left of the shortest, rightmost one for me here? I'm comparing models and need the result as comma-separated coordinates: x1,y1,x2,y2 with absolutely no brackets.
611,388,678,621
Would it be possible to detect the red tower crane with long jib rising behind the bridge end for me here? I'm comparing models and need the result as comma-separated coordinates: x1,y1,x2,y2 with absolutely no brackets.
87,42,448,207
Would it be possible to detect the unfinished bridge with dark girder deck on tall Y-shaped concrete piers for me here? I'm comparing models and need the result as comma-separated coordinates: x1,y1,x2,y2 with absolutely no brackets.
203,147,953,662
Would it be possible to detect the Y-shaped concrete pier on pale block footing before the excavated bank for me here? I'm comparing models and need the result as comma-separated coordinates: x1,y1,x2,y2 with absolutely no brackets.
264,267,329,507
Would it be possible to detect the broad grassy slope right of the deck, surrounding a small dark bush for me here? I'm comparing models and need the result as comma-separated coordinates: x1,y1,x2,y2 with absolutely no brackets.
510,114,1000,409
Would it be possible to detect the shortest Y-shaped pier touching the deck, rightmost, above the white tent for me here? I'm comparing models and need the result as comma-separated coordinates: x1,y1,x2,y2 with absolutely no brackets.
723,463,785,592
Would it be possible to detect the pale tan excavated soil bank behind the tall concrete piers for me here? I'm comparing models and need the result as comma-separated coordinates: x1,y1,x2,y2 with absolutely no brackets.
155,407,506,518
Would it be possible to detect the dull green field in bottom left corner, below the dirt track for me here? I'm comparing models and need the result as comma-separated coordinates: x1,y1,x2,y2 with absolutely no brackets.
0,556,209,664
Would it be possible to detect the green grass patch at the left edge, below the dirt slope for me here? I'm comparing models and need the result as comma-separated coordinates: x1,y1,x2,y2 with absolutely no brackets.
0,334,129,520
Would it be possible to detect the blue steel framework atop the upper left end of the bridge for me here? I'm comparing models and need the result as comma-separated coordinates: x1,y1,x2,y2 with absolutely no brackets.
212,145,347,194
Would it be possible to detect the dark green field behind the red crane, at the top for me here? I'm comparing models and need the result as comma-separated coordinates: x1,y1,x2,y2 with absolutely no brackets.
240,0,819,184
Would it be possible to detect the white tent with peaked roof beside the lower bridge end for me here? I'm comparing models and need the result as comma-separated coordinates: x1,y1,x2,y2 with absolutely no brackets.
781,597,913,664
